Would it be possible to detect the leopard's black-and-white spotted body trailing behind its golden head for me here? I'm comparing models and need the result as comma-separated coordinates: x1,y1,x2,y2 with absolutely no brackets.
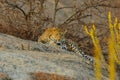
59,39,95,66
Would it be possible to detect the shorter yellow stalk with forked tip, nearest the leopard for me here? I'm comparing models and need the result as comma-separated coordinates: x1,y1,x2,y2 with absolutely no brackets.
85,25,102,80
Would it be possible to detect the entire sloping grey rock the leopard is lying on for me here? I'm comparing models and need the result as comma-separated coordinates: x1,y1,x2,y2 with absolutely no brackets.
0,33,118,80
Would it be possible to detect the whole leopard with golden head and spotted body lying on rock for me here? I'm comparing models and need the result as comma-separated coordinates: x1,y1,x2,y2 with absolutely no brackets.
38,27,94,65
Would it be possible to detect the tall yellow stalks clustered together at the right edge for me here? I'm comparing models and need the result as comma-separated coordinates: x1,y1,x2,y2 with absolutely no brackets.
108,12,120,80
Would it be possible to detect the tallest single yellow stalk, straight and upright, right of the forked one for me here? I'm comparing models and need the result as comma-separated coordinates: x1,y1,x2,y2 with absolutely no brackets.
108,12,115,80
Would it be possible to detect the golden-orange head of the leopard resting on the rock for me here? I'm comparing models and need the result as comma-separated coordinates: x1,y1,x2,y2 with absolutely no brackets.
38,27,66,46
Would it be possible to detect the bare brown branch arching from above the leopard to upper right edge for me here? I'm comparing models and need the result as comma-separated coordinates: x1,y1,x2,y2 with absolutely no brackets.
61,0,120,25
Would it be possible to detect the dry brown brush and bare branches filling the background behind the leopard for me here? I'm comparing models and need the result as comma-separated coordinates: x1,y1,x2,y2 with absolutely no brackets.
0,0,120,54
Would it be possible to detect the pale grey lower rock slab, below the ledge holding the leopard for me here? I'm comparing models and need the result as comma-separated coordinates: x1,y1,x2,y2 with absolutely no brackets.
0,49,94,80
